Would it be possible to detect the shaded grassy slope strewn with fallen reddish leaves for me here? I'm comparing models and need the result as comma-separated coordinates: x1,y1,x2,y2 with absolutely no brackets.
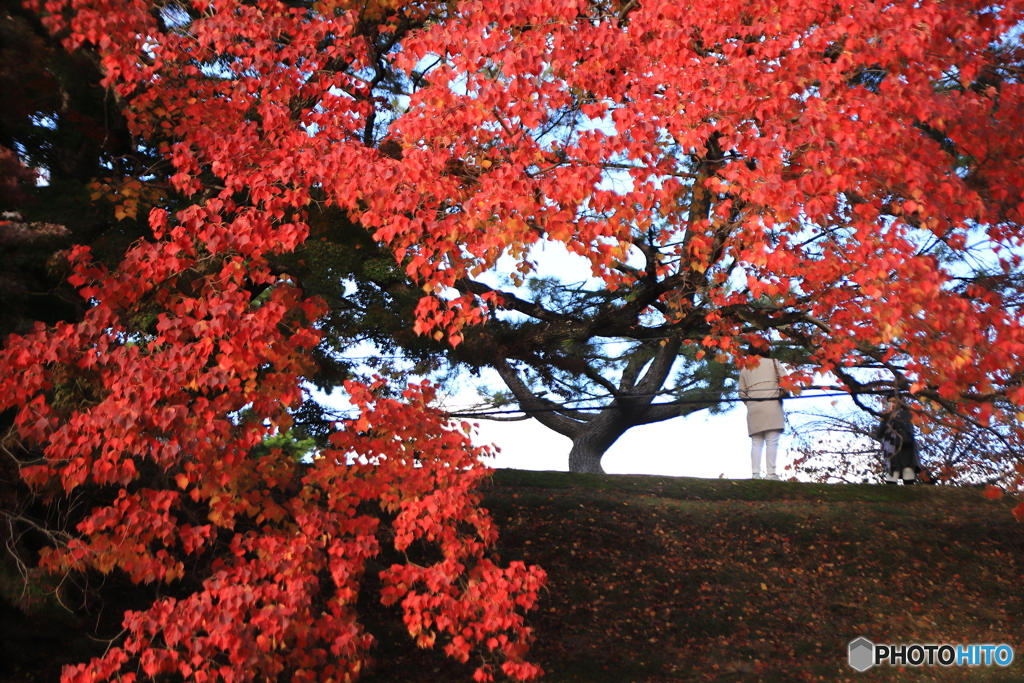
365,470,1024,683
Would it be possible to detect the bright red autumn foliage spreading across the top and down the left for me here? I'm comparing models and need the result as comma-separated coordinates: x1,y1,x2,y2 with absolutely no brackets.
0,0,1024,683
